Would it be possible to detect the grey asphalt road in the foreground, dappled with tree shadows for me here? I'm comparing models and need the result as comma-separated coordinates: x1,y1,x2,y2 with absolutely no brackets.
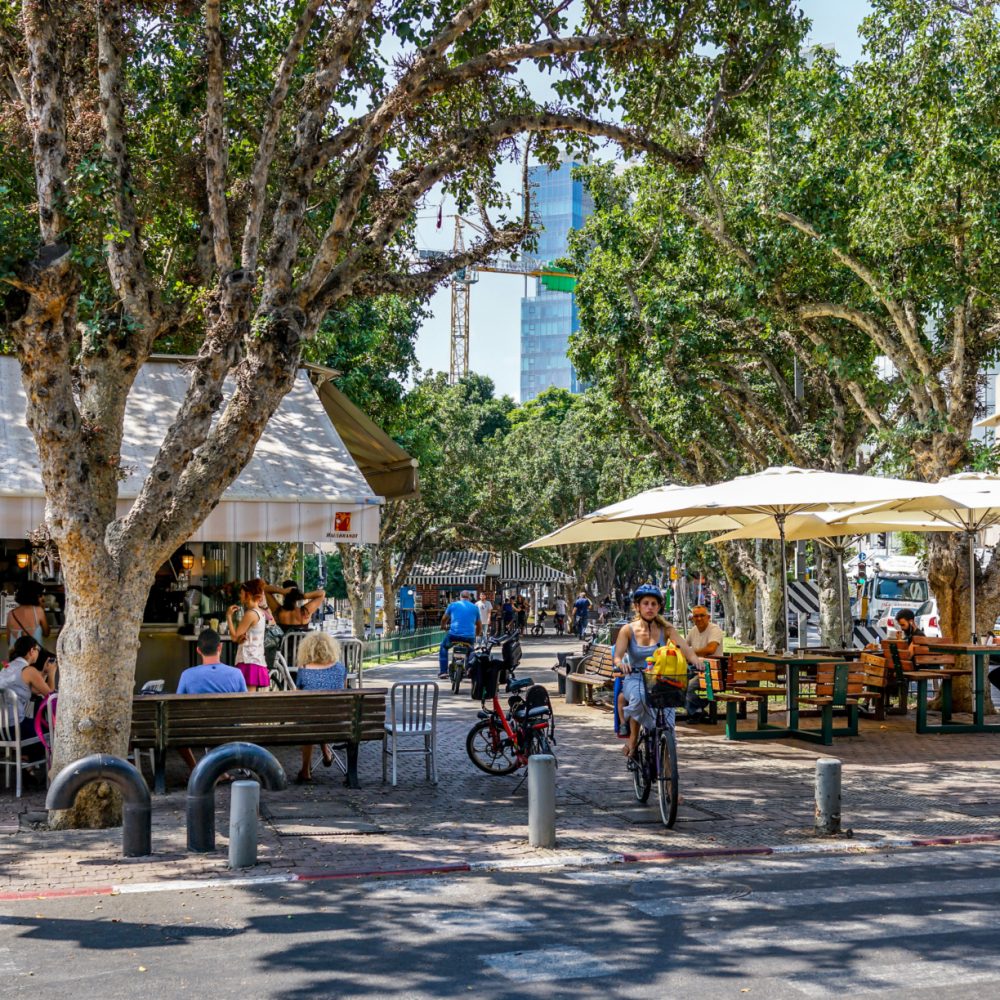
0,847,1000,1000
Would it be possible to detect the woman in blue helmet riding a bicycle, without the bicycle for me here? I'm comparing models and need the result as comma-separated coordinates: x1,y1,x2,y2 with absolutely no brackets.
613,583,698,757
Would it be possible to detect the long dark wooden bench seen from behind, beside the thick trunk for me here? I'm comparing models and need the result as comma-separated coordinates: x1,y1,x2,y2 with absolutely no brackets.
130,688,386,792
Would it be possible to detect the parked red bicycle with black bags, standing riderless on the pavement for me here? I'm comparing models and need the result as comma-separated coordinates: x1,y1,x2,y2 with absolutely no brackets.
465,633,555,775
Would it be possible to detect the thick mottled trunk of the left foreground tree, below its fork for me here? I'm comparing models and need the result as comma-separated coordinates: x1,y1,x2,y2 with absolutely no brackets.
49,564,153,829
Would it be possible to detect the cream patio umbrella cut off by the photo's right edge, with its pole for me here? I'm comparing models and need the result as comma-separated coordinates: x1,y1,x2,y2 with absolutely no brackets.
831,472,1000,641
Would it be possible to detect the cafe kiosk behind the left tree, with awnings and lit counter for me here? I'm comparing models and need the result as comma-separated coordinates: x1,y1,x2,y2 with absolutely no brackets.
0,356,417,691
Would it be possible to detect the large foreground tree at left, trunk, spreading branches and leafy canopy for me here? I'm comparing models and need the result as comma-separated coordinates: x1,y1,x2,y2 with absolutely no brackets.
0,0,798,823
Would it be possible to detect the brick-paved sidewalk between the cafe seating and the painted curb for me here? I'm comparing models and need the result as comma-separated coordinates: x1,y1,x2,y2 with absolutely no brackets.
0,639,1000,893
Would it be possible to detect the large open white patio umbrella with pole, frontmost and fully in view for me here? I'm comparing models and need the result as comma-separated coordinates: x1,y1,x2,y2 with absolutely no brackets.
604,466,936,649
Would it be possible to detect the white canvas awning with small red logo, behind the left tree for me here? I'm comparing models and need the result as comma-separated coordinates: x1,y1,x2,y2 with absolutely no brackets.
0,357,382,543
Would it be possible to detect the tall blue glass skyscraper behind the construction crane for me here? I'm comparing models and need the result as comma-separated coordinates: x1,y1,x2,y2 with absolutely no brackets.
521,161,594,402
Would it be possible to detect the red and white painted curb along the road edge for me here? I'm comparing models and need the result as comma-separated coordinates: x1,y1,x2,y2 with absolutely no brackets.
0,833,1000,902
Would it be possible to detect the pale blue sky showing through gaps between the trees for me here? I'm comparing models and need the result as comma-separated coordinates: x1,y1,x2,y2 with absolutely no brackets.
417,0,871,400
